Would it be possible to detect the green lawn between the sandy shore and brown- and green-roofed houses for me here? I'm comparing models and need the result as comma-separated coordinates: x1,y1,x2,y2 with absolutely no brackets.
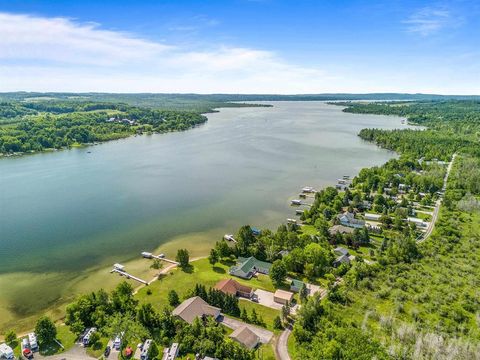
136,259,275,309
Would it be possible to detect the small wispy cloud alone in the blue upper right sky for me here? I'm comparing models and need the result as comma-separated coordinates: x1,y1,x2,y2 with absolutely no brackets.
404,7,462,36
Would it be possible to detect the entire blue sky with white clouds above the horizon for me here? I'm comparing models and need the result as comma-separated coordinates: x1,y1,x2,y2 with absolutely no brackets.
0,0,480,94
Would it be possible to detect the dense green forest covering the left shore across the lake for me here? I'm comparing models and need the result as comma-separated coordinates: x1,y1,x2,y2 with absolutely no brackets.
0,101,207,154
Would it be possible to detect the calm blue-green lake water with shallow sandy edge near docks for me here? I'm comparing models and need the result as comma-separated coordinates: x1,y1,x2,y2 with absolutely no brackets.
0,102,405,330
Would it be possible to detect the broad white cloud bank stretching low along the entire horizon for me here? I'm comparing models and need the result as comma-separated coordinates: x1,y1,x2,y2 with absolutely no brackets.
0,13,480,94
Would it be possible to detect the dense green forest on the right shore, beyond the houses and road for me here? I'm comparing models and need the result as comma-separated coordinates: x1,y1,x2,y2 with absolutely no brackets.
337,100,480,160
